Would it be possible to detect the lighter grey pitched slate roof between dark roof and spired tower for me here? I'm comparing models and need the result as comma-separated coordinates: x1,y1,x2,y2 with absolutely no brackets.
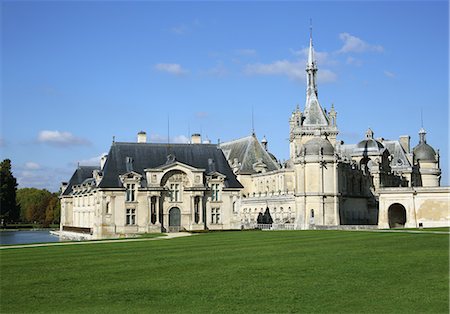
220,134,280,174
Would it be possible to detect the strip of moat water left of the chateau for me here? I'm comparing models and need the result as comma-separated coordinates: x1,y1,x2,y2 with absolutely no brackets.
0,230,59,245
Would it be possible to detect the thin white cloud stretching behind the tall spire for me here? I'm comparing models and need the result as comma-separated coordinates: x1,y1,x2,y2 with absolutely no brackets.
244,60,337,83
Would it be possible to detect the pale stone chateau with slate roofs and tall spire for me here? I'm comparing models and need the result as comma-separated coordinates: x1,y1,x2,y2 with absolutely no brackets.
60,33,450,239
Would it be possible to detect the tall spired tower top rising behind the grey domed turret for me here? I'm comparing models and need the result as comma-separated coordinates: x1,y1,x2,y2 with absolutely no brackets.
289,28,339,160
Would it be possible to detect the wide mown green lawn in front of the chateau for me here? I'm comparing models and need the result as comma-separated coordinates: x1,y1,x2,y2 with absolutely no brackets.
0,231,449,313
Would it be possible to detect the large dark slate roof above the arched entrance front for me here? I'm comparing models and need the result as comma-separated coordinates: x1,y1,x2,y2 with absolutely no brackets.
99,142,243,188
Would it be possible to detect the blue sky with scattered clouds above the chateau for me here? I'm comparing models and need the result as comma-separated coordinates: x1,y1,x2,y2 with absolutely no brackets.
0,1,449,191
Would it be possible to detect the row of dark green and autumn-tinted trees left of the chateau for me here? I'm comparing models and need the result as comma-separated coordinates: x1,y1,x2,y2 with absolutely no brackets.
0,159,60,226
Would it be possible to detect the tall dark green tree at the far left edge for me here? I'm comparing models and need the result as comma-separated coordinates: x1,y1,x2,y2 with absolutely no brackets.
0,159,19,221
